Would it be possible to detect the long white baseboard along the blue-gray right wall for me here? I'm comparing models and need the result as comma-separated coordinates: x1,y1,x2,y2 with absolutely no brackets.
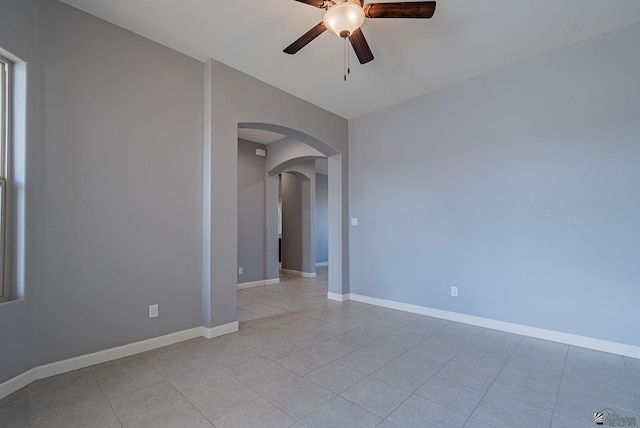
348,293,640,358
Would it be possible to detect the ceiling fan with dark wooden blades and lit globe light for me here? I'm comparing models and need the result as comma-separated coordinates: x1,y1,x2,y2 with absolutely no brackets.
284,0,436,65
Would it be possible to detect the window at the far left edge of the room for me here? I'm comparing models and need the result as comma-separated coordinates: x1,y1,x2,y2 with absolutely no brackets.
0,56,11,302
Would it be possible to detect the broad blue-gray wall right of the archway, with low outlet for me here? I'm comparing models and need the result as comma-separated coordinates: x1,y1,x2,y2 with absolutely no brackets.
349,24,640,345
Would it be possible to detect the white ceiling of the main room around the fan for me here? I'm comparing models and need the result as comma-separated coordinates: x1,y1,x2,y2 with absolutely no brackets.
62,0,640,119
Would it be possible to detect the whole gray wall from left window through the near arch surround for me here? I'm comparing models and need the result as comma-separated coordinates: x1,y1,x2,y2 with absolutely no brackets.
0,0,348,381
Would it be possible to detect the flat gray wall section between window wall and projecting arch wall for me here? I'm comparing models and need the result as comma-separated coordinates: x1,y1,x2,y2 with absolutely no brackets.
34,1,203,364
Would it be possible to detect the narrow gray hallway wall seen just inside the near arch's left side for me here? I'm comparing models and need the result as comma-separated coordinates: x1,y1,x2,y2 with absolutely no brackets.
238,140,267,284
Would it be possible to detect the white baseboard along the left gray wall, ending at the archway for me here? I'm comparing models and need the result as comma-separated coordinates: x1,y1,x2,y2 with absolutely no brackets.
0,321,240,399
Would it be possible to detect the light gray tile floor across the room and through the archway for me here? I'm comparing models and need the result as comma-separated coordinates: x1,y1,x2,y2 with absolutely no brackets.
0,270,640,428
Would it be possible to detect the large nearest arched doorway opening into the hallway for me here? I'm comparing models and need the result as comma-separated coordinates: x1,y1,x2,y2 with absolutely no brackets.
238,123,342,304
